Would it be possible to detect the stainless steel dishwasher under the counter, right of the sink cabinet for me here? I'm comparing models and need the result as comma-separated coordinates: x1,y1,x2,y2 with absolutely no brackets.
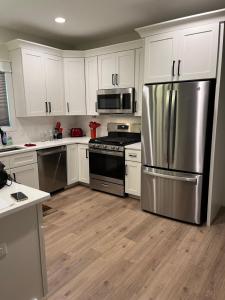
37,146,67,193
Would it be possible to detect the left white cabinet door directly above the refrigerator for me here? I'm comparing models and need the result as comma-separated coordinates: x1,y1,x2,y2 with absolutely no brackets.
144,32,177,83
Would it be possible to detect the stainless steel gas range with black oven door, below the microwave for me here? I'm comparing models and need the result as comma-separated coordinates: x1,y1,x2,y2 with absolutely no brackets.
89,123,141,196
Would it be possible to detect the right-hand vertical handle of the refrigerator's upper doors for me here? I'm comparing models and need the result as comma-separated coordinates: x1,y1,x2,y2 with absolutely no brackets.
168,90,177,167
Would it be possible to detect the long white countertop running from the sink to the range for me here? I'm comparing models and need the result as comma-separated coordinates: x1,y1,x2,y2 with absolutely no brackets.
0,136,90,157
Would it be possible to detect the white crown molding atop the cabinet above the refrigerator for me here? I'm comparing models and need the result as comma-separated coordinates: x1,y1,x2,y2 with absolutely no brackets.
135,9,225,38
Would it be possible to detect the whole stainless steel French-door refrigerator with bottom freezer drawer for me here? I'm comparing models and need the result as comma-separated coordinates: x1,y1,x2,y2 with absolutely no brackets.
141,81,213,224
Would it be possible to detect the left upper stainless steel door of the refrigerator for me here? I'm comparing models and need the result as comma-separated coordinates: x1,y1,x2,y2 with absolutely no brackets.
142,84,172,169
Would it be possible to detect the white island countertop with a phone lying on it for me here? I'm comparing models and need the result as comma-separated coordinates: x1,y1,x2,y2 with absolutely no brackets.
0,183,50,218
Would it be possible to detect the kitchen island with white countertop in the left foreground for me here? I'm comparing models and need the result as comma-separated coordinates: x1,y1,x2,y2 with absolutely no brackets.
0,183,50,300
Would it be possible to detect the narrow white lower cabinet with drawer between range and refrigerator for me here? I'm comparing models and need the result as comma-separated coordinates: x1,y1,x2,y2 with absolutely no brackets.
125,150,141,197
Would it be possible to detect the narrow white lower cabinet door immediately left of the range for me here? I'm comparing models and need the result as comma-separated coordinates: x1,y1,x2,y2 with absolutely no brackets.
78,145,90,184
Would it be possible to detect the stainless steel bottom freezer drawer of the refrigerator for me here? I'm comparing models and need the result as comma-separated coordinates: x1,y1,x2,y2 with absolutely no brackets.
141,167,203,224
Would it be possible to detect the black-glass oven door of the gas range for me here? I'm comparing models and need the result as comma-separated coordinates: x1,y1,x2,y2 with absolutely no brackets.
89,149,125,185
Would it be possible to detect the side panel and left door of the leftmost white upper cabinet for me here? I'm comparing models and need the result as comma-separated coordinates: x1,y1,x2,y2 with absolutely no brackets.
11,49,47,117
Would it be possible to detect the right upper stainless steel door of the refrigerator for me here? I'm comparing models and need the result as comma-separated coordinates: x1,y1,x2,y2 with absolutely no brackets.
169,81,210,173
